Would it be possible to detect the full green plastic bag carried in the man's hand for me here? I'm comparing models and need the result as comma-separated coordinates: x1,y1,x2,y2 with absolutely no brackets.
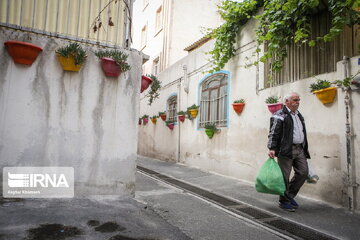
255,158,286,196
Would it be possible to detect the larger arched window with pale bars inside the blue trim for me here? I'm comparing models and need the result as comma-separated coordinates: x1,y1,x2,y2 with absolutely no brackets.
199,72,228,127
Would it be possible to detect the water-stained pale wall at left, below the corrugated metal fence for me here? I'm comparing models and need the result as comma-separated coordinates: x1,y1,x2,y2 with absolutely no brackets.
0,28,142,196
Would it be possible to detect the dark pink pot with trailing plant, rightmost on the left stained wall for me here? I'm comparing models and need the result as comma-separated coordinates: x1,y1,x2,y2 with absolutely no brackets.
95,50,131,77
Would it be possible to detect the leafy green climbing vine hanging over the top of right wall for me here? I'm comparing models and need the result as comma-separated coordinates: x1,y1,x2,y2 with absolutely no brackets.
208,0,360,72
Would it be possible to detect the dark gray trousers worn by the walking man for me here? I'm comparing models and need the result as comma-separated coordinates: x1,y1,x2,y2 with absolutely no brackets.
278,144,309,202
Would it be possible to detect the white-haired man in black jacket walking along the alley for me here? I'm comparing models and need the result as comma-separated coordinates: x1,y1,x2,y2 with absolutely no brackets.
268,92,310,212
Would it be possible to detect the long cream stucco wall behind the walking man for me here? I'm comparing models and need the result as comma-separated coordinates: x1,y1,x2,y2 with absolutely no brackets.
139,21,360,210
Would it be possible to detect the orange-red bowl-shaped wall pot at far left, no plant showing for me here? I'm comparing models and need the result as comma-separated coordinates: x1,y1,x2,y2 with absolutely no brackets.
4,41,42,65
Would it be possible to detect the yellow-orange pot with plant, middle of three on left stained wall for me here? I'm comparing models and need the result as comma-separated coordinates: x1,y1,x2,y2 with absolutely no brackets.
56,43,87,72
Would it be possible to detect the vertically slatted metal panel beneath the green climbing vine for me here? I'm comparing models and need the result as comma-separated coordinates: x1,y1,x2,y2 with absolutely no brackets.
264,12,360,87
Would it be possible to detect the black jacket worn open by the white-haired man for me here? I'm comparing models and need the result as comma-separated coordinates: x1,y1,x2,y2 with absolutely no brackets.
268,106,310,158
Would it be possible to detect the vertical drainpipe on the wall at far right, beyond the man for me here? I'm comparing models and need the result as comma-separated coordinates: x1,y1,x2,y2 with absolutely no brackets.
343,56,357,211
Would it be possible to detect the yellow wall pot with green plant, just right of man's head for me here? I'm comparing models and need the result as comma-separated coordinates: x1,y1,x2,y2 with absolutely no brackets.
310,79,336,104
